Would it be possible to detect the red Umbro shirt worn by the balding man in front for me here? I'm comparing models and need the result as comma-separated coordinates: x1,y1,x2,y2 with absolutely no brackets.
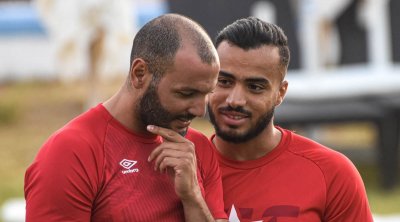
25,104,226,222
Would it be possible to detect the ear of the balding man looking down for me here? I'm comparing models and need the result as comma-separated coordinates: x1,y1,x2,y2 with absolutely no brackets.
129,58,150,89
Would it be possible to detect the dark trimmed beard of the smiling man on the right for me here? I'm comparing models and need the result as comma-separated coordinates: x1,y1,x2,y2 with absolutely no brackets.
207,104,275,143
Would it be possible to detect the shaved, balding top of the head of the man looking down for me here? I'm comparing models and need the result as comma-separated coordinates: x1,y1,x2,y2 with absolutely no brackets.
130,14,218,80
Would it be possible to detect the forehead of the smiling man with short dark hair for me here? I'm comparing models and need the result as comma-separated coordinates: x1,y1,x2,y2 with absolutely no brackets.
217,41,282,79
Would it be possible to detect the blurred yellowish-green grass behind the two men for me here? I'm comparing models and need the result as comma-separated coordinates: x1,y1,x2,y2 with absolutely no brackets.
0,79,400,214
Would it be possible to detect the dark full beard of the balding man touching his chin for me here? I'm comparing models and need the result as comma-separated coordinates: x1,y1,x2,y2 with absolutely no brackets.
136,82,195,136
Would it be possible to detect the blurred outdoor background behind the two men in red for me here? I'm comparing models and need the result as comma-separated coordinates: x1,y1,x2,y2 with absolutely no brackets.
0,0,400,221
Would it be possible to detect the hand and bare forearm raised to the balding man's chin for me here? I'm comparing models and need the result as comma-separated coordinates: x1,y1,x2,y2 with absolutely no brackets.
148,126,222,221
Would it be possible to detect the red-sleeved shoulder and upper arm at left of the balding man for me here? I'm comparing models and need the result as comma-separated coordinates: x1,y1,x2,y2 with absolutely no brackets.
24,105,111,221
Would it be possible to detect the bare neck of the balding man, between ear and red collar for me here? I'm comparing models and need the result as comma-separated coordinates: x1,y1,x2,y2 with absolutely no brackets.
103,86,151,134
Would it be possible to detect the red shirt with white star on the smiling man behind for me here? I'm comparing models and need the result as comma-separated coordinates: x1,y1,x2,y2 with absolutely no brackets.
211,127,373,222
